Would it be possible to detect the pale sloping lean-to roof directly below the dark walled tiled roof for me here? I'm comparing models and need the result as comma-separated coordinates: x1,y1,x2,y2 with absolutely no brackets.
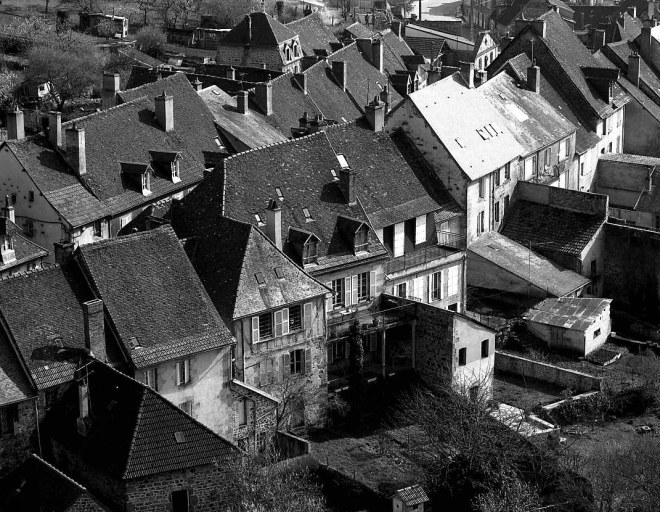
468,231,591,297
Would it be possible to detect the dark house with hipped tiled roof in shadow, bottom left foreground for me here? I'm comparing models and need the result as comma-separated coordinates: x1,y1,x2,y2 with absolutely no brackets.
43,361,240,512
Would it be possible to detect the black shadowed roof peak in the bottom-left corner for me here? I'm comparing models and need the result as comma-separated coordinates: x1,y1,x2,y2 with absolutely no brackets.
0,454,107,512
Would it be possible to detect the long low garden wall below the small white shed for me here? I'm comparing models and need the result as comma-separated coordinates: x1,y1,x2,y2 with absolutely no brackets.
495,351,601,393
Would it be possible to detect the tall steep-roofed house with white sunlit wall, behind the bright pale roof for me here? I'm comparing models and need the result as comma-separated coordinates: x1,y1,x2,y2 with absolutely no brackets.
488,11,630,192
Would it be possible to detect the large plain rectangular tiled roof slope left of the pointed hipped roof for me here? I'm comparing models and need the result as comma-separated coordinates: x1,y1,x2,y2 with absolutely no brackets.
78,226,235,368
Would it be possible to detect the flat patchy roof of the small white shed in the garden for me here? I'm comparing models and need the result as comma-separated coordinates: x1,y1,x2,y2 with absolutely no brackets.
523,297,612,331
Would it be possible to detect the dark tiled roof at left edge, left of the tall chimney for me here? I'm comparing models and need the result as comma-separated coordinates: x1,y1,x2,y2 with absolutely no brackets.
0,265,94,390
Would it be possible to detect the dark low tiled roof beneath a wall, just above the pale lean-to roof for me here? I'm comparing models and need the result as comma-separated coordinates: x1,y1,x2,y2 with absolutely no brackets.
500,200,604,256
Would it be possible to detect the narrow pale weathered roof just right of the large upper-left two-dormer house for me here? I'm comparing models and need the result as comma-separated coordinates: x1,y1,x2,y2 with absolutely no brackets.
199,86,287,149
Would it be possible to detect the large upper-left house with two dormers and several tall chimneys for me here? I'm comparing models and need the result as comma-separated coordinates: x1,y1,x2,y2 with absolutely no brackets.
0,75,220,262
